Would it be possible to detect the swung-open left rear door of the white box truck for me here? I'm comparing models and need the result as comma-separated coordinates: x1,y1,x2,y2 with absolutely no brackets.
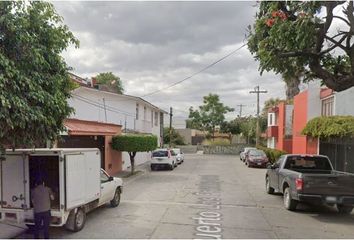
0,154,30,209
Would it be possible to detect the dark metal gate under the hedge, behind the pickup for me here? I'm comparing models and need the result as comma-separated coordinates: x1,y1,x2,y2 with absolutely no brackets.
320,138,354,173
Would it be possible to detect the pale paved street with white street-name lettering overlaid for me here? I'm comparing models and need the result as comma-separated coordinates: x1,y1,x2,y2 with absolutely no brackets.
21,155,354,239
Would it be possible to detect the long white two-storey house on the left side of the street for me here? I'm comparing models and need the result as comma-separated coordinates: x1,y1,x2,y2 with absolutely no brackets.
68,84,166,170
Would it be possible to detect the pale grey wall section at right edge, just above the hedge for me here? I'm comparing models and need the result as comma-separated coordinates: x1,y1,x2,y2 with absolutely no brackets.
334,87,354,116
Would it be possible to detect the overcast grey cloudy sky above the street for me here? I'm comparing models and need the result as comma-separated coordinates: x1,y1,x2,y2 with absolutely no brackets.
54,1,285,127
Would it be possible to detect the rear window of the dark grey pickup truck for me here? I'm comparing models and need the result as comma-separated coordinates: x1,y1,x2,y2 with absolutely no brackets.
285,156,332,170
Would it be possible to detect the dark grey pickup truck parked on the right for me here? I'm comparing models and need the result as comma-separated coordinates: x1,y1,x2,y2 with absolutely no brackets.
265,154,354,214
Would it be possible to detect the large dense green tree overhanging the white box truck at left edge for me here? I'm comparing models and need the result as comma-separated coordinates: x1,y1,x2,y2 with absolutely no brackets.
0,1,78,153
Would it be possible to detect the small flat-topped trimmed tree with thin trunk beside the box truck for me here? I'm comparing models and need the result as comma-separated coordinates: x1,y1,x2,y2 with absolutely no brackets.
112,135,157,174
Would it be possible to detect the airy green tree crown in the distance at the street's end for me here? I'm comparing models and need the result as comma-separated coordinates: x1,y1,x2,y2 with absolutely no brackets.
188,93,234,139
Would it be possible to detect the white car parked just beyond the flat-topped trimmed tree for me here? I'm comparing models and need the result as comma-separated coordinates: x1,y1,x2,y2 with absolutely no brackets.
150,148,177,170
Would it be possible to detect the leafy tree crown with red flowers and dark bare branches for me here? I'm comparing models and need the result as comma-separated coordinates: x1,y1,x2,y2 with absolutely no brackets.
248,1,354,91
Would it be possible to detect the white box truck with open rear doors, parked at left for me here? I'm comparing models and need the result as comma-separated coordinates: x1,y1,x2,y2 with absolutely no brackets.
0,148,123,231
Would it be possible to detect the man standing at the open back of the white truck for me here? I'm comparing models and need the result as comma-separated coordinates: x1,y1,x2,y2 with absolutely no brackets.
31,177,54,239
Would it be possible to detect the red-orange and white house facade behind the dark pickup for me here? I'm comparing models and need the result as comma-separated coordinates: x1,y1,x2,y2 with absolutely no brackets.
267,81,354,172
